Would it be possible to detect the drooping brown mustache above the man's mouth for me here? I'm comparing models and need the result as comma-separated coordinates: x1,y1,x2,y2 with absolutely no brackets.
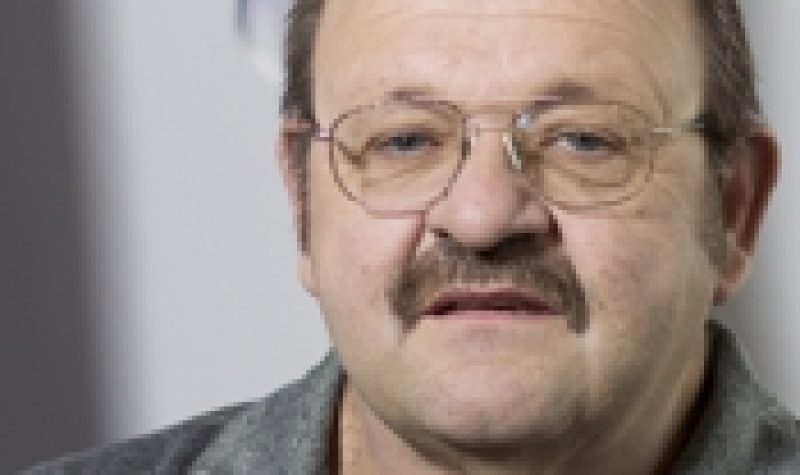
387,233,588,333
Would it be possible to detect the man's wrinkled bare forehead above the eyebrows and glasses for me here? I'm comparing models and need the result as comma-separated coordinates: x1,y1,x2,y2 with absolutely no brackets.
315,0,705,119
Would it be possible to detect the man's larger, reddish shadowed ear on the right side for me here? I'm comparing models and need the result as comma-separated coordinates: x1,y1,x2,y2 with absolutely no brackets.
714,125,780,305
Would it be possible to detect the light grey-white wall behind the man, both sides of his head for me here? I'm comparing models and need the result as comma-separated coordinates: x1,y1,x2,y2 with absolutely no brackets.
73,0,800,437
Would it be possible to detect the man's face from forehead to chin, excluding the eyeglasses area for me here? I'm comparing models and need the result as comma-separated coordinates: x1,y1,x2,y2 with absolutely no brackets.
302,0,716,443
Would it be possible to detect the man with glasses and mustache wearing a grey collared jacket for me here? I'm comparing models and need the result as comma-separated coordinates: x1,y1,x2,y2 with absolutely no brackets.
23,0,800,474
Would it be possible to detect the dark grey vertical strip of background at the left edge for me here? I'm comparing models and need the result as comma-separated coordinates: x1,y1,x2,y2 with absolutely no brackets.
0,0,99,473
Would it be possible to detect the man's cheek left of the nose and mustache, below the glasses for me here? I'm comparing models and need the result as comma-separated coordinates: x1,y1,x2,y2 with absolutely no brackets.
307,152,421,342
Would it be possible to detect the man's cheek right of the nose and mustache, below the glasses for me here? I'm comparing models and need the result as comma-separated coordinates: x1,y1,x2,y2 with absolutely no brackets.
564,150,710,318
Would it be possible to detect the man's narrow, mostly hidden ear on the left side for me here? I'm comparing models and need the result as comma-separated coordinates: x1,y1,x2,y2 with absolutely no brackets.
276,115,318,297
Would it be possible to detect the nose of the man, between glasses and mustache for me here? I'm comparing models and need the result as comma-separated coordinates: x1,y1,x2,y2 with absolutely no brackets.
426,129,555,249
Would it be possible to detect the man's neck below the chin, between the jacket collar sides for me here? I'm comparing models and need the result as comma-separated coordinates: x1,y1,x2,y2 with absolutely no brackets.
337,338,708,475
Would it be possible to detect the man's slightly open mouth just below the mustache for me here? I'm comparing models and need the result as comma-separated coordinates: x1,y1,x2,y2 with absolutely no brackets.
423,290,561,320
